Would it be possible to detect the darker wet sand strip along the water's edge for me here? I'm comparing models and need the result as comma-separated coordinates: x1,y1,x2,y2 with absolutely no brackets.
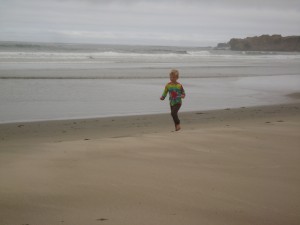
0,102,300,141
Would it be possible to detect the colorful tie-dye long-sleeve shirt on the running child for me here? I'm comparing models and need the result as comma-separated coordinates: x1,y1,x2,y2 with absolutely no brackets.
162,82,185,106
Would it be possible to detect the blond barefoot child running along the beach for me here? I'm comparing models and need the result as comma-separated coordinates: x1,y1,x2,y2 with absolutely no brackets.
160,70,185,131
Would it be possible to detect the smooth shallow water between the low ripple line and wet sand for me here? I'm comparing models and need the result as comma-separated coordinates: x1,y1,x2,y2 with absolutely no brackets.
0,75,300,124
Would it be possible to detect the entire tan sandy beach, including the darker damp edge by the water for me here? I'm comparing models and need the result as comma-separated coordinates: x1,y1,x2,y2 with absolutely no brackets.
0,104,300,225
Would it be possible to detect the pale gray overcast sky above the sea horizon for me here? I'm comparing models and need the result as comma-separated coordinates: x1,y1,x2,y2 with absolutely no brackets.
0,0,300,46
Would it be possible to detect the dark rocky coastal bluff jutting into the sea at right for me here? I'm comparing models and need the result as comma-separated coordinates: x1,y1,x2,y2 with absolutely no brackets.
228,35,300,52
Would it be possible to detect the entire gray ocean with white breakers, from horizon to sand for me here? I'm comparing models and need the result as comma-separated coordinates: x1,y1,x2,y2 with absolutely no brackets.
0,42,300,123
